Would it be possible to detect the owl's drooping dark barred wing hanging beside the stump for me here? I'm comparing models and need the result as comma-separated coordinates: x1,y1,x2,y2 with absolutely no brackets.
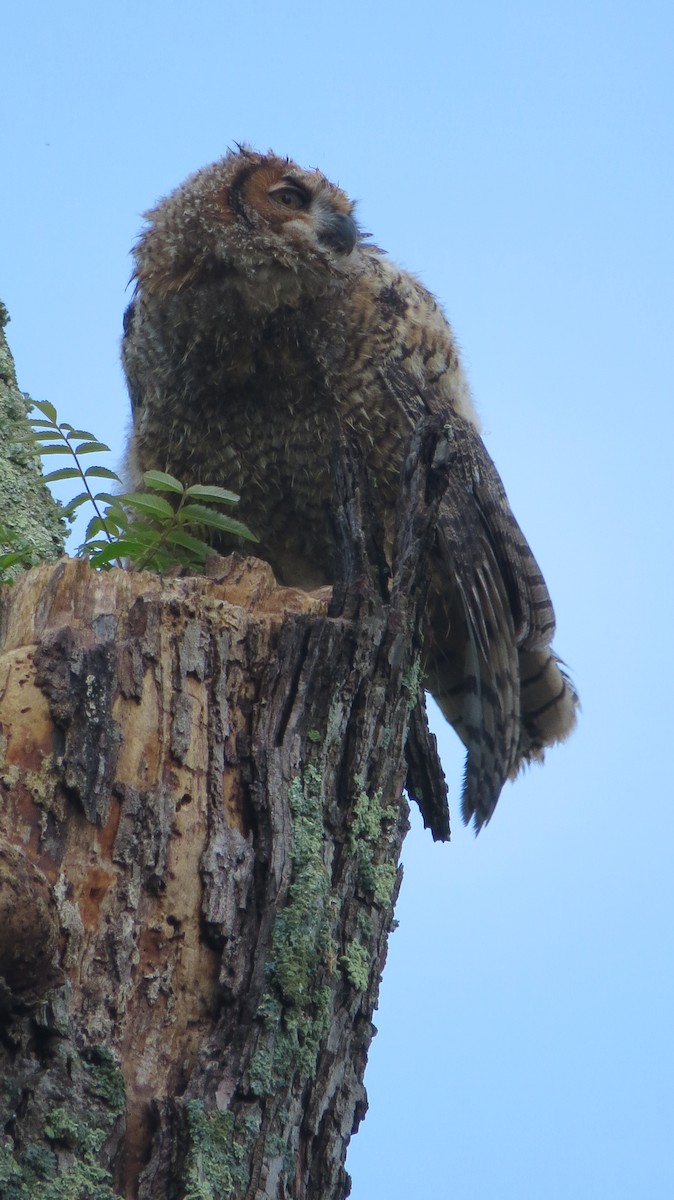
386,368,558,829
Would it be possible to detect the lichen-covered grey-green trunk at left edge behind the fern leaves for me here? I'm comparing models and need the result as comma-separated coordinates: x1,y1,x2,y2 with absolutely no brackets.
0,302,67,570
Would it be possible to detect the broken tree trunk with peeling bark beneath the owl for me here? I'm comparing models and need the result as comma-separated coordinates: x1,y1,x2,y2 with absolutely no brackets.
0,422,449,1200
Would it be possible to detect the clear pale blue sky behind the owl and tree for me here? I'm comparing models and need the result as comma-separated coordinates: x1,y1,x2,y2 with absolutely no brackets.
0,0,674,1200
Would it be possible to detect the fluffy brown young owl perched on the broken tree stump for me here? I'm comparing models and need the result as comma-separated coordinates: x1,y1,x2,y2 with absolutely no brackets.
122,149,577,829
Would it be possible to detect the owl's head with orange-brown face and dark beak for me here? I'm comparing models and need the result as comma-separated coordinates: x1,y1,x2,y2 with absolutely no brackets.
134,146,362,307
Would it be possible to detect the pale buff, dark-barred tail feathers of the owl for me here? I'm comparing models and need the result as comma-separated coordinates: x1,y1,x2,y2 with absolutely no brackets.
510,648,579,779
